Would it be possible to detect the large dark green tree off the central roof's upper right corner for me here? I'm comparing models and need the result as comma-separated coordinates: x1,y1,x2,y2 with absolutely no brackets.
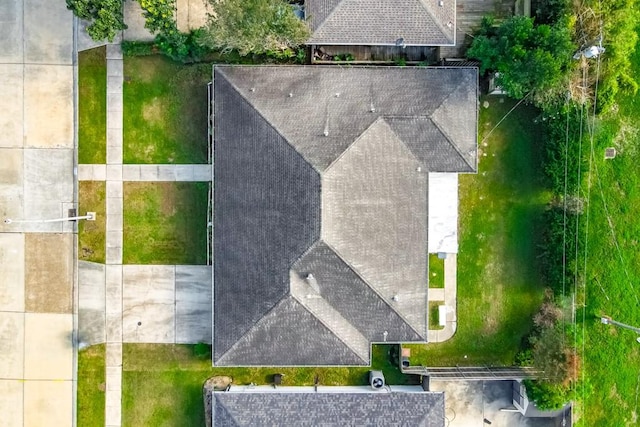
467,16,575,98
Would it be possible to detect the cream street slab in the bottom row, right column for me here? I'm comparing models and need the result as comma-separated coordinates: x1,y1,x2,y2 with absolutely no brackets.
24,381,74,427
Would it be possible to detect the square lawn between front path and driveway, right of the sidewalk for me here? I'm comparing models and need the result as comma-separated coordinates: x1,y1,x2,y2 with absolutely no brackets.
123,182,209,264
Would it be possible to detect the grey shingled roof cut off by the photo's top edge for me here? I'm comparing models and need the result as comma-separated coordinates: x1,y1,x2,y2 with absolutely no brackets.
305,0,456,46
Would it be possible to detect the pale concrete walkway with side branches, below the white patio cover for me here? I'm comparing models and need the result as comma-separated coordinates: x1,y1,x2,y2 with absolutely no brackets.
428,254,458,343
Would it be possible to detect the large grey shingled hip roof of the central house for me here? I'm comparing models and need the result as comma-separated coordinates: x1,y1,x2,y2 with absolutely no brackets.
213,66,477,366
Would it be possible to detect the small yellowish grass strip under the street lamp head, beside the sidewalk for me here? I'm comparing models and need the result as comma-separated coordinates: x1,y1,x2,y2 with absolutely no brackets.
78,181,107,264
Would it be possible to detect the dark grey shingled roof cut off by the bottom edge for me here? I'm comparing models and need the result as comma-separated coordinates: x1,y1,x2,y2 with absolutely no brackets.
212,387,445,427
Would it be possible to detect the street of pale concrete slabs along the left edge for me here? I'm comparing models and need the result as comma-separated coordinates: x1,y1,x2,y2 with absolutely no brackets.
0,0,75,427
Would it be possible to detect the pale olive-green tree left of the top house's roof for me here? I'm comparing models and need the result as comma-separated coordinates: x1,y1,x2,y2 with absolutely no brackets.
198,0,310,55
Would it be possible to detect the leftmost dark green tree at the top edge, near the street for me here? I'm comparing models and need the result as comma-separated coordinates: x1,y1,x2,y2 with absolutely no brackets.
66,0,127,42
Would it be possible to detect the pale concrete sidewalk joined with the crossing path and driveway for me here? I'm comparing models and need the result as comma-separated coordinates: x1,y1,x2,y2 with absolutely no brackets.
77,44,211,427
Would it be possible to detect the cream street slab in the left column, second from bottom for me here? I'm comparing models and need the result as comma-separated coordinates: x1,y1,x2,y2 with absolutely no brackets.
0,312,24,380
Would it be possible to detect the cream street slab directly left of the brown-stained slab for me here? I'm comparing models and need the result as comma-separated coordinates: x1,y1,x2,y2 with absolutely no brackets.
0,233,24,312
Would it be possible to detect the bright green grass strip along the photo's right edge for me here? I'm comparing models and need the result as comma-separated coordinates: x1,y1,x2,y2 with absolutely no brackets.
577,38,640,426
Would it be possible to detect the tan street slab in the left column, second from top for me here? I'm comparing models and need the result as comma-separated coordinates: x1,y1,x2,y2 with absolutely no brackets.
0,64,24,147
